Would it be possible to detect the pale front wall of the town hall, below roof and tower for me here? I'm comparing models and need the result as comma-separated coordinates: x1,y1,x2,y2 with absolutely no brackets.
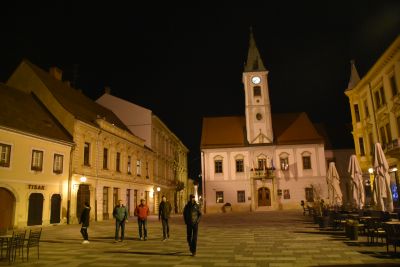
202,145,327,213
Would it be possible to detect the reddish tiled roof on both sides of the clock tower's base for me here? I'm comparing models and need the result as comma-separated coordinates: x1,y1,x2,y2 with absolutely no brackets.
200,112,324,148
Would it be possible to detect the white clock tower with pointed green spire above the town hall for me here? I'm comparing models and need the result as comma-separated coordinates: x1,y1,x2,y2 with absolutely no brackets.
243,29,273,144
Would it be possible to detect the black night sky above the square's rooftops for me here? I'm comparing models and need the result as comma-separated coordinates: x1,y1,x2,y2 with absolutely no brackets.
0,1,400,180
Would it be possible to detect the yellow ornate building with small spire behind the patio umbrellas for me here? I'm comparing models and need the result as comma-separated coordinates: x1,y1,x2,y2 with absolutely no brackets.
345,37,400,207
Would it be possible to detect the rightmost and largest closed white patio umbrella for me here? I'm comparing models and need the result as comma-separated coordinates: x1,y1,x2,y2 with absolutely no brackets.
372,143,393,212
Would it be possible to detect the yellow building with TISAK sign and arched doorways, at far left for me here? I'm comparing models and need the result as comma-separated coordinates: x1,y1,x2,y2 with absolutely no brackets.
0,84,73,229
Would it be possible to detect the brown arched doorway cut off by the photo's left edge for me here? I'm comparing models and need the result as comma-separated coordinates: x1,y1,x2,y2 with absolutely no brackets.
0,187,15,230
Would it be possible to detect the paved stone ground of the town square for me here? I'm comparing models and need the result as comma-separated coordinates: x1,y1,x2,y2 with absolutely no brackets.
0,211,400,267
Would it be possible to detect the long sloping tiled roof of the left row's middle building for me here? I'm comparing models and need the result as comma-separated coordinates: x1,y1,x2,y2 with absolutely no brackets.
23,60,130,132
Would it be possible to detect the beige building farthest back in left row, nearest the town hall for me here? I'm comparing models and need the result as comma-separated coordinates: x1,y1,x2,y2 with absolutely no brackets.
96,91,192,212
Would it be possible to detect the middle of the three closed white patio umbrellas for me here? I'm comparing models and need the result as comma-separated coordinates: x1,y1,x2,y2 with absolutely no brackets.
348,155,365,209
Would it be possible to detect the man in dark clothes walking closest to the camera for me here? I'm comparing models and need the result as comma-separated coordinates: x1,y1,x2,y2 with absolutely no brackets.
183,195,201,256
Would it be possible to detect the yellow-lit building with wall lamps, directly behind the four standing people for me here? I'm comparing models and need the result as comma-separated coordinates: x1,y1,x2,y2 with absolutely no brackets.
7,60,156,223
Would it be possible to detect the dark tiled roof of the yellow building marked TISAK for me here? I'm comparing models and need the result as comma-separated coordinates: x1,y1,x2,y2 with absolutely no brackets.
0,83,72,143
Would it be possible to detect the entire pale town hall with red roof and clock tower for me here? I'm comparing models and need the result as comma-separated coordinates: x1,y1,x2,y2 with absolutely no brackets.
201,31,327,213
